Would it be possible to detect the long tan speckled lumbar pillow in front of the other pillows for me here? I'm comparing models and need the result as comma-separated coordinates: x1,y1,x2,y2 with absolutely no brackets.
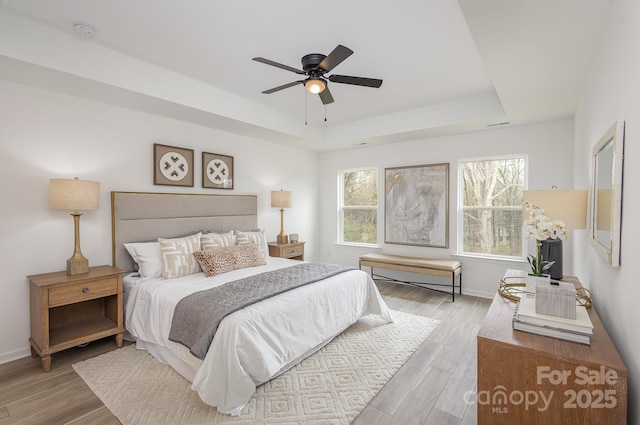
193,243,267,277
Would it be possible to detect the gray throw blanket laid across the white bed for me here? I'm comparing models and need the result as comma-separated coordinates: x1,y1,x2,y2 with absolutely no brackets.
169,263,355,360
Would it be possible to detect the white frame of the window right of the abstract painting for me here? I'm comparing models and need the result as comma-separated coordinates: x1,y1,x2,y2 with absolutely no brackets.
456,154,529,262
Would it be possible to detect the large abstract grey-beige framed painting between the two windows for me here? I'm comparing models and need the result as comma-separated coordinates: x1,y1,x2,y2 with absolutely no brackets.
384,163,449,248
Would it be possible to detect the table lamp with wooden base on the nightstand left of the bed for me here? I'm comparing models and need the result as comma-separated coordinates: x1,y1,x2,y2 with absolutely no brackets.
49,177,100,275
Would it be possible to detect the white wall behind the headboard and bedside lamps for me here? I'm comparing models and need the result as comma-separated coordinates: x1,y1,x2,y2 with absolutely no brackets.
0,81,318,363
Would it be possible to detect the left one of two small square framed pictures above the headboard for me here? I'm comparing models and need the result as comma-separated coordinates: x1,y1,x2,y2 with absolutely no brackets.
153,143,193,187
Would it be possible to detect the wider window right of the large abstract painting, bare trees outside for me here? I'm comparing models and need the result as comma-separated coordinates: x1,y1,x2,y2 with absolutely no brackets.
458,157,526,258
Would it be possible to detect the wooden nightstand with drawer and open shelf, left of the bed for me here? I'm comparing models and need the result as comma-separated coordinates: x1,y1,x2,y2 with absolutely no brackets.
27,266,124,372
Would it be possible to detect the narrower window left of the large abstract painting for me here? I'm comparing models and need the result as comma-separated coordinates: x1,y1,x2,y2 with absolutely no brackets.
338,168,378,245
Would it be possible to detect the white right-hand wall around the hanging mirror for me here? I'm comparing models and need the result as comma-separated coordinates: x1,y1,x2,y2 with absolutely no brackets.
574,0,640,424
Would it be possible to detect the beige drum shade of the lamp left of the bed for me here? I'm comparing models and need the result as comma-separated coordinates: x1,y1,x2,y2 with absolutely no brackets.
49,177,100,210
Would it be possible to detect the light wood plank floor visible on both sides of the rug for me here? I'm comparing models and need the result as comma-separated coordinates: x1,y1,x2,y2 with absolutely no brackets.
0,282,490,425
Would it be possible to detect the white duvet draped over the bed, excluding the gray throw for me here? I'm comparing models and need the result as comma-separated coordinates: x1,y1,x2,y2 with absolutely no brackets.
125,257,392,415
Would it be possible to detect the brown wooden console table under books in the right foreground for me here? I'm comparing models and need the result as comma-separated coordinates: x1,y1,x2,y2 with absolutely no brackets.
475,278,627,425
